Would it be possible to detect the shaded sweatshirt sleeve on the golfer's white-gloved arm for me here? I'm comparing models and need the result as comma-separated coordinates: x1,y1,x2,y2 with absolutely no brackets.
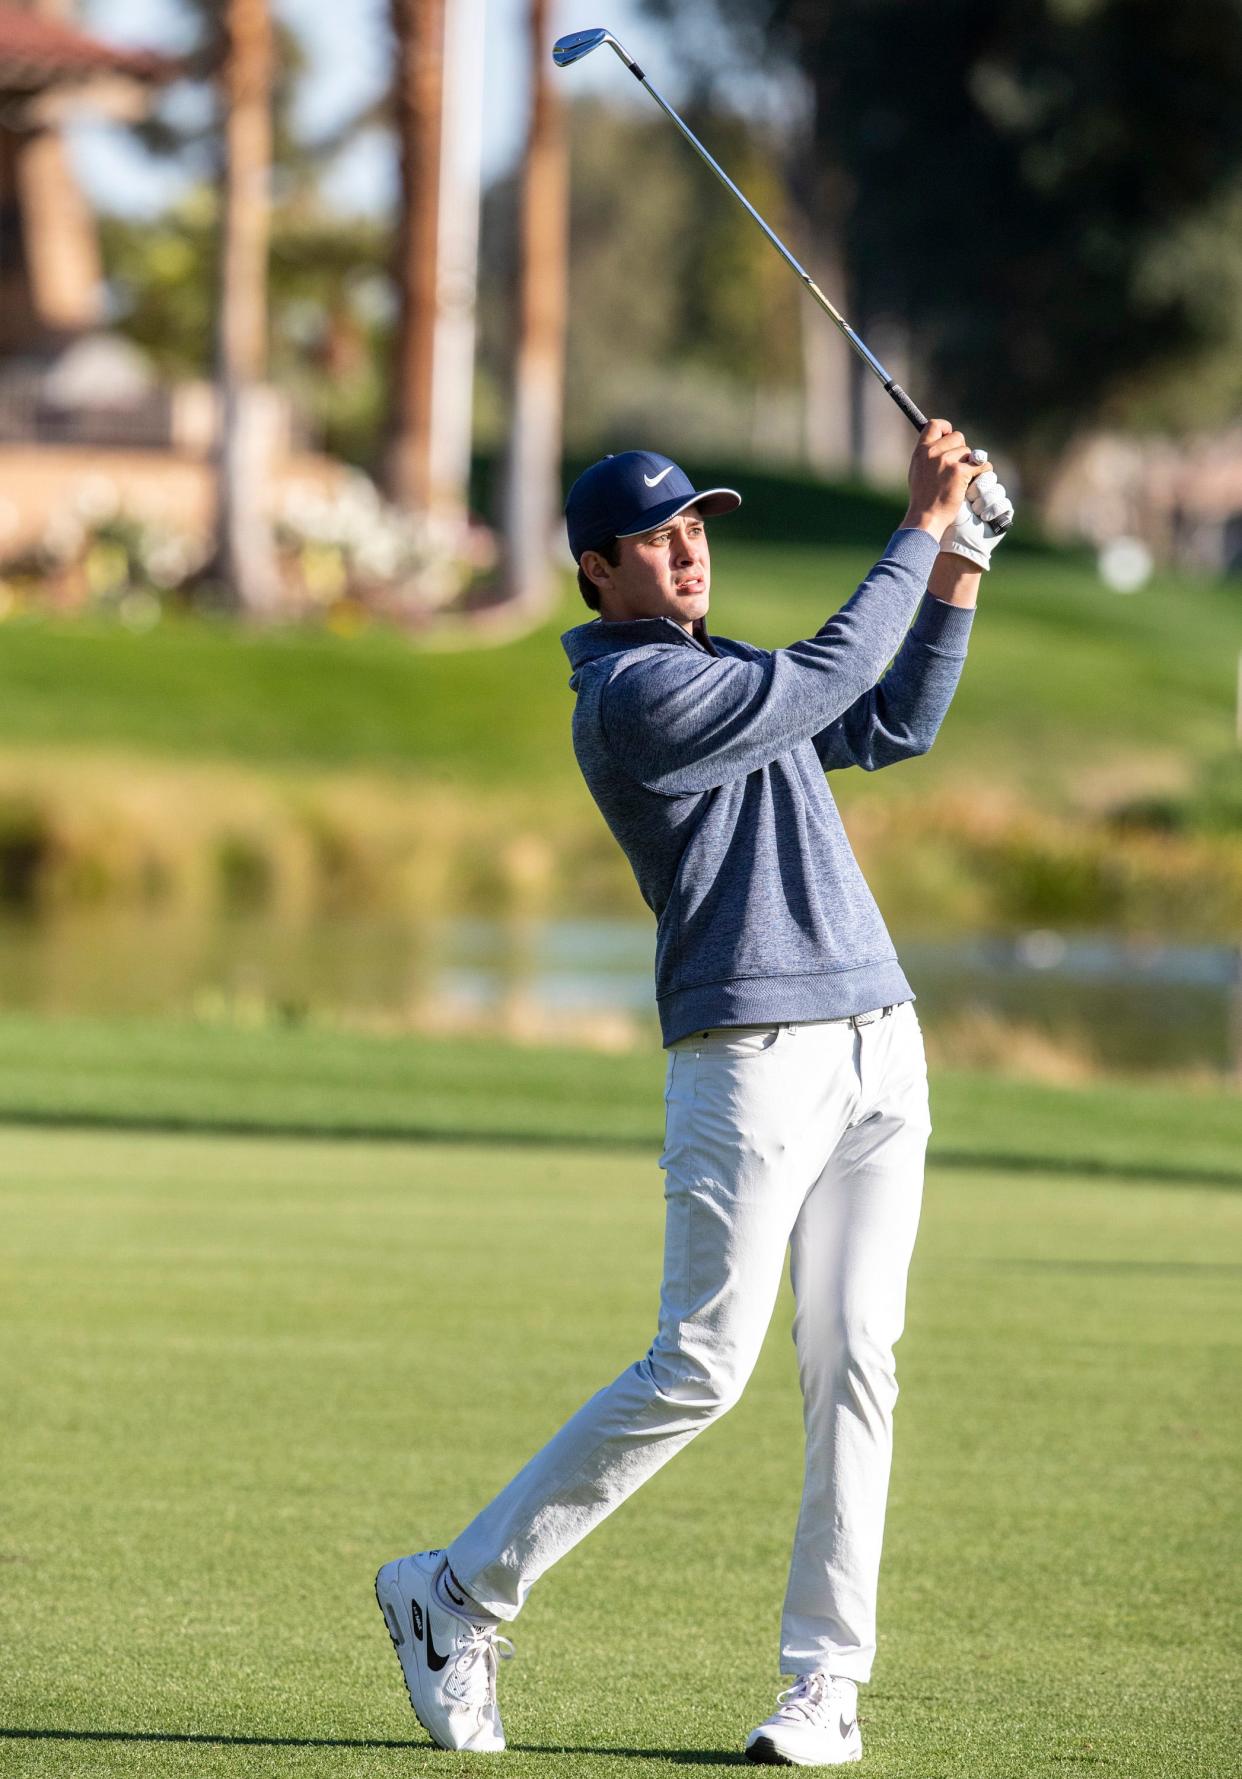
815,592,975,772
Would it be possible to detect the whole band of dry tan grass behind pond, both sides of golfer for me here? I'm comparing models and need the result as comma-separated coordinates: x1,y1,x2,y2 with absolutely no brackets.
0,749,1242,939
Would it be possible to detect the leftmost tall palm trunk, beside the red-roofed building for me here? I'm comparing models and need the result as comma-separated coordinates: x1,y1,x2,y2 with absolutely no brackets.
215,0,279,616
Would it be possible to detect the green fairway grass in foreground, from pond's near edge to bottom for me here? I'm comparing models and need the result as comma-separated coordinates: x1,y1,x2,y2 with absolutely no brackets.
0,1016,1242,1779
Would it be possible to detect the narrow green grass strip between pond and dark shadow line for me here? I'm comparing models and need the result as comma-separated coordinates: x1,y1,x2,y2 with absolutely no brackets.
0,1010,1242,1187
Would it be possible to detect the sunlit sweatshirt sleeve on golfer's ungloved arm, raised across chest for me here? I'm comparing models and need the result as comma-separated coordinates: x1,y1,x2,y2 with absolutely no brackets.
600,530,938,795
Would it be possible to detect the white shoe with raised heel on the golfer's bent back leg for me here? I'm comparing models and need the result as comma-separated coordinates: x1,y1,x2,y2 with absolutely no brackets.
375,1551,512,1754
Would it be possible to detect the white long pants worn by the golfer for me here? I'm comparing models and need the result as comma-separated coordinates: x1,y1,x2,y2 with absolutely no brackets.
448,1002,931,1681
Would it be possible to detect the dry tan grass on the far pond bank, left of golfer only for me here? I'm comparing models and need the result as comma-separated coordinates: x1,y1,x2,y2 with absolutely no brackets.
0,751,615,923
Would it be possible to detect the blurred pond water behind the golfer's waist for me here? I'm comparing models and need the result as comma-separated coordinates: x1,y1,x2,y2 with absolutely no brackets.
0,914,1242,1075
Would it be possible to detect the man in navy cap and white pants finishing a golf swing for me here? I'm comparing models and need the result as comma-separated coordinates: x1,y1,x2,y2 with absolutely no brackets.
375,420,1012,1767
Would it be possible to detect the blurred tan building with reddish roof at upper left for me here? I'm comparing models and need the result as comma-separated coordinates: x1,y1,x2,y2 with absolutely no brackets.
0,0,329,560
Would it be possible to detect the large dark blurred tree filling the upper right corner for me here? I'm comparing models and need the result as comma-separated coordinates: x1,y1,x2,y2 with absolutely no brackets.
648,0,1242,473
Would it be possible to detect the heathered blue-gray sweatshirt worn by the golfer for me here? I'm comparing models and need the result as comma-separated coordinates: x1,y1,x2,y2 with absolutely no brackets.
561,530,973,1044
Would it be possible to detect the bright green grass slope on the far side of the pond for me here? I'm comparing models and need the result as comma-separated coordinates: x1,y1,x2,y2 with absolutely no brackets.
0,526,1238,806
